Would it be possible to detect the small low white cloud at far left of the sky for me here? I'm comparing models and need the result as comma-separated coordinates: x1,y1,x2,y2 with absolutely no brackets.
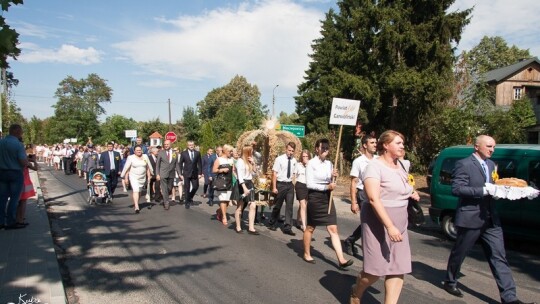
19,43,101,65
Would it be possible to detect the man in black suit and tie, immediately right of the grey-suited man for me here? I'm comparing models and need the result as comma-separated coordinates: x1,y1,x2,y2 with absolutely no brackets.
180,140,202,209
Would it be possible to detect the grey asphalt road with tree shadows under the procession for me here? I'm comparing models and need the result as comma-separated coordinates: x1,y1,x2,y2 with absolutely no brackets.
40,167,540,304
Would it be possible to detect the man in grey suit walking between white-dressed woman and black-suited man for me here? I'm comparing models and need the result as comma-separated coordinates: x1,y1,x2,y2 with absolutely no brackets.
156,140,180,210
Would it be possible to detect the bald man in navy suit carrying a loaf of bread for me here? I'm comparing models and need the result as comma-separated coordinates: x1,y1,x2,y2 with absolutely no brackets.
444,135,536,304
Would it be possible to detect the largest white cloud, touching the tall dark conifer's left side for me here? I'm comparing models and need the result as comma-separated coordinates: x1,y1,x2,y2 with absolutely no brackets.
115,0,324,89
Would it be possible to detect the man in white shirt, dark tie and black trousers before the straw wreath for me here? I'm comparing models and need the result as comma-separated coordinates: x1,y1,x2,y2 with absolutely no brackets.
268,142,296,236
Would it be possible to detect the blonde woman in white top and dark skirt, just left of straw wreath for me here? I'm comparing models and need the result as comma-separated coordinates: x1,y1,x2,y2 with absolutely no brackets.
234,146,259,235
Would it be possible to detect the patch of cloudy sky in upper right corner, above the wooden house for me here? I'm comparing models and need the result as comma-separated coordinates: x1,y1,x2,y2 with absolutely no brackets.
450,0,540,56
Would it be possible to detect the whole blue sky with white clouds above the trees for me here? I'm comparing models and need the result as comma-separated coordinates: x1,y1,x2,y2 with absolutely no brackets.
4,0,540,122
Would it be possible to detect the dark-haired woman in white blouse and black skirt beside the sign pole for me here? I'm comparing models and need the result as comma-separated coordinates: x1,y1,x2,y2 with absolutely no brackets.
304,139,353,268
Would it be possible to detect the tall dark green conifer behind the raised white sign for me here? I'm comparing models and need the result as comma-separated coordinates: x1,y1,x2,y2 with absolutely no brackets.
296,0,471,147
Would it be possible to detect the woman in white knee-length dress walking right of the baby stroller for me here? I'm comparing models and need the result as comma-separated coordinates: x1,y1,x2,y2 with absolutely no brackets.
120,146,152,213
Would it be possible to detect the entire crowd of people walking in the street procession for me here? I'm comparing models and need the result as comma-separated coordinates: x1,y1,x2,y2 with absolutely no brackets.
0,125,523,304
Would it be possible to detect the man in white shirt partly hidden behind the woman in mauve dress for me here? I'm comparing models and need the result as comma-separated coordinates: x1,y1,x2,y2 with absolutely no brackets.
343,135,377,255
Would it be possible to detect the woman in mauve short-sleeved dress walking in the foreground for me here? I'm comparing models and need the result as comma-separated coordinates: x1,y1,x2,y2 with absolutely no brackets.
350,130,420,303
